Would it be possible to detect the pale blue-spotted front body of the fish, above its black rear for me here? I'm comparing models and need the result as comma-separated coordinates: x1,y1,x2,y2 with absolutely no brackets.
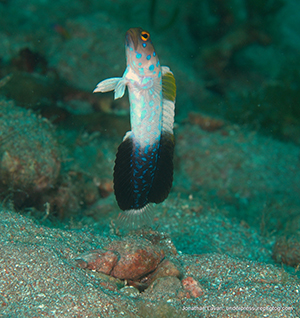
124,35,163,147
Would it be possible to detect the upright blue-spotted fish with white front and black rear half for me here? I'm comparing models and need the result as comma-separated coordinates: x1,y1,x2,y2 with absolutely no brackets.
93,28,176,227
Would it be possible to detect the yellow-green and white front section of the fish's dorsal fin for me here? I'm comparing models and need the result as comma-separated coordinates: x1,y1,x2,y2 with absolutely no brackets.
162,66,176,134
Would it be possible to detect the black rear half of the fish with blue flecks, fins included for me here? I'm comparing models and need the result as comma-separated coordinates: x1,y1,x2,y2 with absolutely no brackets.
114,133,174,211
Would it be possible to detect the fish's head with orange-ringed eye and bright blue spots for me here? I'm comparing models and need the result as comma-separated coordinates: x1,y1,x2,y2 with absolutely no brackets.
125,28,161,77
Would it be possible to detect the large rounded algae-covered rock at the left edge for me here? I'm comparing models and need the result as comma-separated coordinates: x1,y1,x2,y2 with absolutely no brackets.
0,101,61,200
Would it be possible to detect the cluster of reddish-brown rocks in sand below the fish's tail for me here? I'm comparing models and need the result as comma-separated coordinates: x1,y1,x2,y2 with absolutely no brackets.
75,237,182,291
